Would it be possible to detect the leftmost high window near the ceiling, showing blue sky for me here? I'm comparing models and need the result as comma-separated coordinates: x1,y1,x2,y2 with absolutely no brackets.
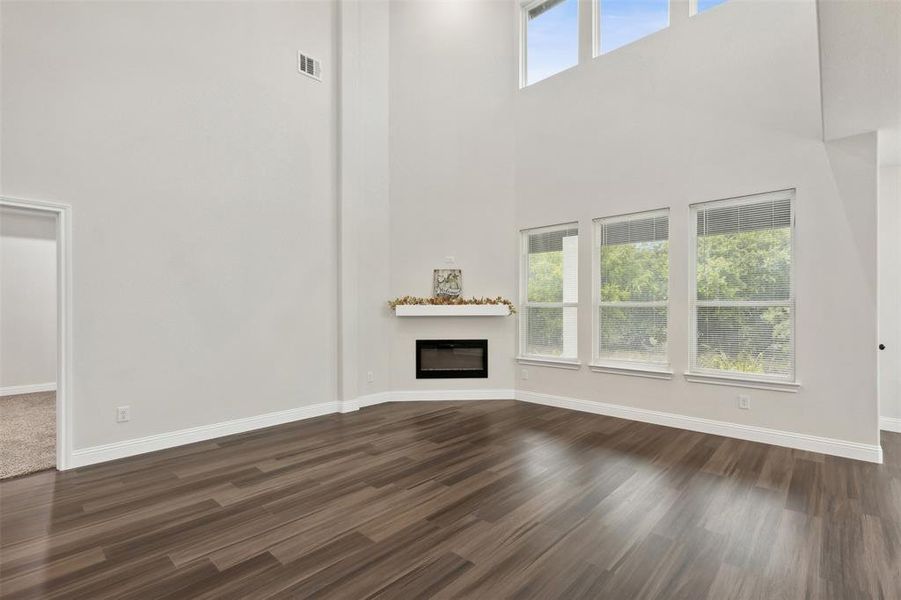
522,0,579,86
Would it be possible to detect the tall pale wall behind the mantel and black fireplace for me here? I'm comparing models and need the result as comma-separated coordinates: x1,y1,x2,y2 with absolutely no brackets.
390,0,517,390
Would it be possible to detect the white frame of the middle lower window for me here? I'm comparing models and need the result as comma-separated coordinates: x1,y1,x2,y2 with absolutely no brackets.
590,207,672,378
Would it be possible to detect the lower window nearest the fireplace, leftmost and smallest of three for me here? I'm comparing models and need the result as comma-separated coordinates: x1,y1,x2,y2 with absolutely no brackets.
519,223,579,361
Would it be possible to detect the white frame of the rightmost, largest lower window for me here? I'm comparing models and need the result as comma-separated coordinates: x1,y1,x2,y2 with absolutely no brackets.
685,188,800,384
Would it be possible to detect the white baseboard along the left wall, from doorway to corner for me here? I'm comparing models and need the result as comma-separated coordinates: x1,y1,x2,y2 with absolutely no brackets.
69,401,340,468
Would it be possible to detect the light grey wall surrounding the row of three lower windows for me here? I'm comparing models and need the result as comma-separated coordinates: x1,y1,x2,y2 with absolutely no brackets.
516,1,878,444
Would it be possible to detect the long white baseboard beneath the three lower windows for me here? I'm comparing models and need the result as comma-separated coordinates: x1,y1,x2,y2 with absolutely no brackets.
516,390,882,463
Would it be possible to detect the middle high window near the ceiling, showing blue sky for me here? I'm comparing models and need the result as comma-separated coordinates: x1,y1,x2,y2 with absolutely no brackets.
595,0,668,54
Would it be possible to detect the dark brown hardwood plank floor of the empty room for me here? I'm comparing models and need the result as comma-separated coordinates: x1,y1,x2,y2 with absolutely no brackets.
0,401,901,600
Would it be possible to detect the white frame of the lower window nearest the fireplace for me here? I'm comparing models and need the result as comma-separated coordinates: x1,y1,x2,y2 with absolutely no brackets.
516,221,582,360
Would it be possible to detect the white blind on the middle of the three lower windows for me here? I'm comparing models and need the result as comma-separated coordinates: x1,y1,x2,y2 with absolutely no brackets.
595,210,669,364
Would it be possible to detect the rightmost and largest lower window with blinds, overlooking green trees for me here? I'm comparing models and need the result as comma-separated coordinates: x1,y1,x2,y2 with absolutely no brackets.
690,190,795,381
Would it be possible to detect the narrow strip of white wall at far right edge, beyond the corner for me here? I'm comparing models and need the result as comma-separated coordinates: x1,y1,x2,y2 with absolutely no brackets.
879,165,901,429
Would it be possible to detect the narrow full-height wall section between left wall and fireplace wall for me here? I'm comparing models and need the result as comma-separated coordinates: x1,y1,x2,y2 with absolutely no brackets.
340,0,393,400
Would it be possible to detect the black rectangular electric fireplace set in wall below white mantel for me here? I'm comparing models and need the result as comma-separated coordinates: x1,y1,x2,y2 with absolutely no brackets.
416,340,488,379
